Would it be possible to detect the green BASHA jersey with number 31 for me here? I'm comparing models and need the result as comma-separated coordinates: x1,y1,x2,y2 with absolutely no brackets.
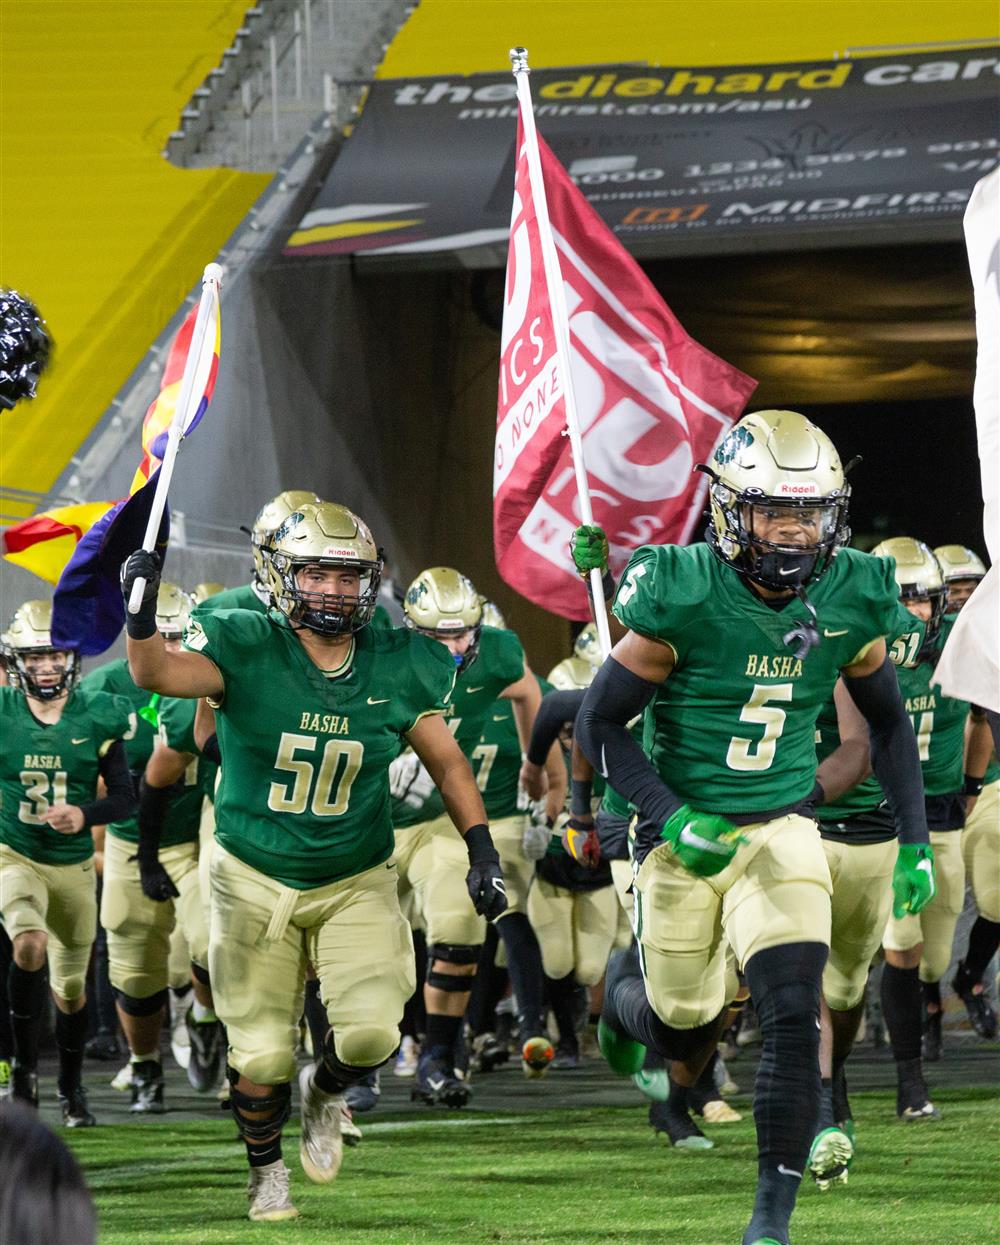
0,686,132,864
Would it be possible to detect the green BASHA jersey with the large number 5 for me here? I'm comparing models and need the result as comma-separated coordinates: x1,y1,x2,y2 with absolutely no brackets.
610,544,898,817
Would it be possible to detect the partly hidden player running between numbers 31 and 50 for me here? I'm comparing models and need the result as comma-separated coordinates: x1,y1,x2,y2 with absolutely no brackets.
101,580,220,1114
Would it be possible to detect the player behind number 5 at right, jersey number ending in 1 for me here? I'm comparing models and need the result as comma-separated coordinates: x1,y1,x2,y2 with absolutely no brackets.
873,537,969,1061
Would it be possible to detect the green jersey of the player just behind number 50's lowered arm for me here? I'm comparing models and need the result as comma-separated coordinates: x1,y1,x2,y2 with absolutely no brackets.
392,626,524,829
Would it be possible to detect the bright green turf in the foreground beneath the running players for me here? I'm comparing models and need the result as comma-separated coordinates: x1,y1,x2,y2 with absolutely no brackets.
64,1077,1000,1245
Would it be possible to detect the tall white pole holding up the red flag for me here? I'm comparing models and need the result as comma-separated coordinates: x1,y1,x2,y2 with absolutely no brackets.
511,47,611,657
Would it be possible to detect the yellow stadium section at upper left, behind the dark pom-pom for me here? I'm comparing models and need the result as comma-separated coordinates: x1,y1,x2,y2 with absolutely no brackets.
0,0,270,510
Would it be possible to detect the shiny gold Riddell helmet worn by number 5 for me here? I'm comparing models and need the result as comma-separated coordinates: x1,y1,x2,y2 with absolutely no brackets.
700,411,851,590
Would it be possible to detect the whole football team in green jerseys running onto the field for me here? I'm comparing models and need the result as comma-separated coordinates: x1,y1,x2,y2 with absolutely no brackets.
0,411,1000,1245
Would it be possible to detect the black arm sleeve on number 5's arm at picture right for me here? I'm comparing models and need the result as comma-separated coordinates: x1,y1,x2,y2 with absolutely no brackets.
844,657,930,844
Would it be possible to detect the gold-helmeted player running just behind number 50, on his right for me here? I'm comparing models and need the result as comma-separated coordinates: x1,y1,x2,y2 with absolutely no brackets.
392,566,550,1107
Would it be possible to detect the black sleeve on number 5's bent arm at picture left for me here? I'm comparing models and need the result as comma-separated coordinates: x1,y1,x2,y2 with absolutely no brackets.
577,657,684,825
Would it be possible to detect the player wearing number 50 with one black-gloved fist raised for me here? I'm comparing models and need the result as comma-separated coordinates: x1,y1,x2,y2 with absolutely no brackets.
122,503,503,1220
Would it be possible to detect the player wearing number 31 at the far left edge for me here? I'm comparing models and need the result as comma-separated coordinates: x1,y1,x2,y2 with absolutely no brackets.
0,601,134,1128
